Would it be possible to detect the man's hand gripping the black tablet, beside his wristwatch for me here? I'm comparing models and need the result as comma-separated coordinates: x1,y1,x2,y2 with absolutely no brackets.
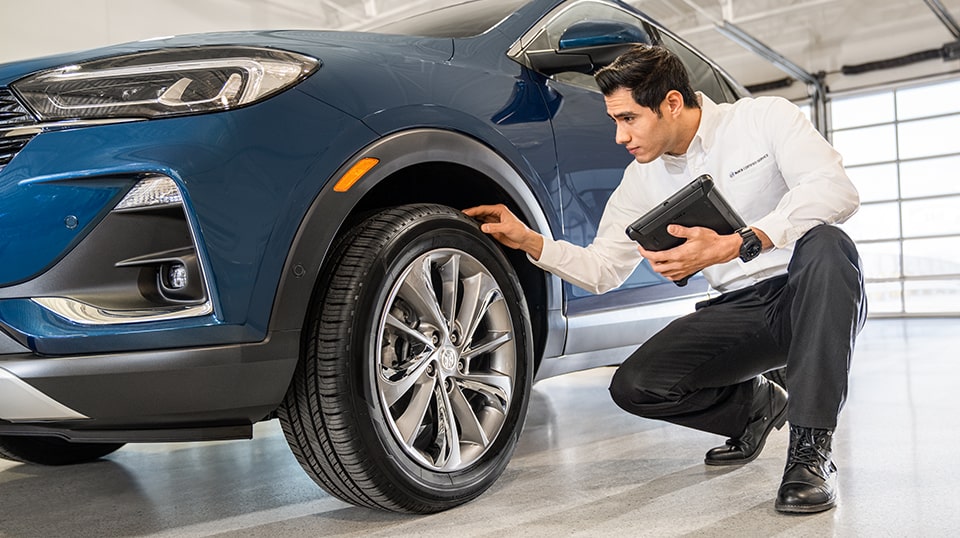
638,224,743,281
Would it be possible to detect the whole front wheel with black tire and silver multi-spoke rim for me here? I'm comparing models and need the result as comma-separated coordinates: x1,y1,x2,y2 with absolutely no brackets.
279,205,533,513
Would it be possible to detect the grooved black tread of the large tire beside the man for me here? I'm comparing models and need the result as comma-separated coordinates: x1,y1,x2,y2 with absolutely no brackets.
279,205,454,513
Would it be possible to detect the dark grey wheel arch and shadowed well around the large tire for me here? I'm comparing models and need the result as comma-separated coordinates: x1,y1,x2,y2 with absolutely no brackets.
271,129,565,372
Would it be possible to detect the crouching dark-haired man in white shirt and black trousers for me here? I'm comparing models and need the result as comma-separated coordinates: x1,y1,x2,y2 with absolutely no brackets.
465,45,866,513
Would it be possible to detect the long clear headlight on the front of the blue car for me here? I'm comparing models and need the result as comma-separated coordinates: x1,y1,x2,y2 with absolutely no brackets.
12,47,320,121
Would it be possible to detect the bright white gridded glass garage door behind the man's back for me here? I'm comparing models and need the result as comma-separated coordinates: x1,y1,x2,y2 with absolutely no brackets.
831,79,960,317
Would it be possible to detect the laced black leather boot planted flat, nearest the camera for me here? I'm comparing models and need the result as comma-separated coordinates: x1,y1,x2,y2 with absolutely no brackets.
775,424,837,514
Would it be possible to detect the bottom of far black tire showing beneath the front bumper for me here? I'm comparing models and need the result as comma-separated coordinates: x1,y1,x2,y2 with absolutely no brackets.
0,435,124,465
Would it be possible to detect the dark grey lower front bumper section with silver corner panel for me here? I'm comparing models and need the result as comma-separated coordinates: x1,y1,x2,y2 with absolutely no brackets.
0,331,299,442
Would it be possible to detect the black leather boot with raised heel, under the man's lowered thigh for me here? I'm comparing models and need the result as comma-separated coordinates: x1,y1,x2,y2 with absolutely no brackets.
703,376,787,465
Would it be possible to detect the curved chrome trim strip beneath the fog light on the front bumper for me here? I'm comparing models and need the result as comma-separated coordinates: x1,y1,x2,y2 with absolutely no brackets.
30,297,213,325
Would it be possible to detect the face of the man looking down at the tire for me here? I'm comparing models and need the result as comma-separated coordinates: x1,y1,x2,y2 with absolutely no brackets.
603,88,676,163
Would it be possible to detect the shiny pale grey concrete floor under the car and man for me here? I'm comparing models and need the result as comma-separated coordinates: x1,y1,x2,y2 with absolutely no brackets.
0,319,960,538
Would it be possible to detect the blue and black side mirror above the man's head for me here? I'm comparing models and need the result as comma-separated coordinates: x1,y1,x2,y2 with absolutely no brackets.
527,21,650,76
